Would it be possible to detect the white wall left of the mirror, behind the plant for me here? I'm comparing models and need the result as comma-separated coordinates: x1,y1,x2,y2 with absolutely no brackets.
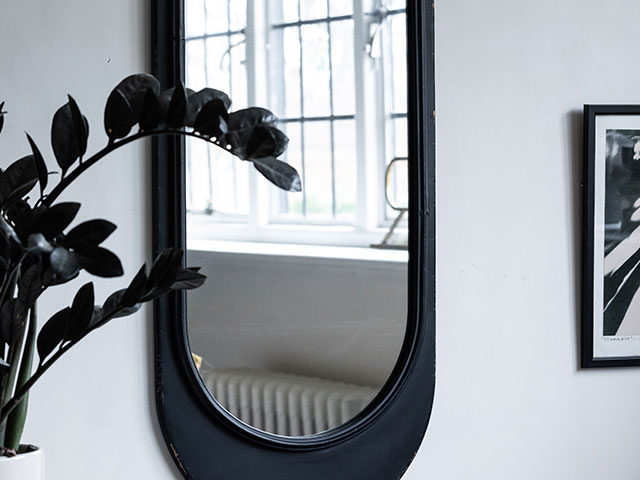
0,0,177,480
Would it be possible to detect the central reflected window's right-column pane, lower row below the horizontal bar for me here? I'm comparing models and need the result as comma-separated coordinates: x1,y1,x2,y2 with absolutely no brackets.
333,120,358,218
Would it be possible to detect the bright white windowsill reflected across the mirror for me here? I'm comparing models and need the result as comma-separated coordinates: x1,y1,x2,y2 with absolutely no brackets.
188,240,409,263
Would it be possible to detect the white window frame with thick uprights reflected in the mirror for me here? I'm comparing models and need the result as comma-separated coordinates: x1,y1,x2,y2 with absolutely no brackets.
187,0,406,247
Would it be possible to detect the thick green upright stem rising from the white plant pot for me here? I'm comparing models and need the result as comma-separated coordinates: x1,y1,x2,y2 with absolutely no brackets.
4,303,38,450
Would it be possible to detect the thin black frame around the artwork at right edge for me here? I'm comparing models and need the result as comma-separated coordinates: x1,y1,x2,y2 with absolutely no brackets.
580,105,640,368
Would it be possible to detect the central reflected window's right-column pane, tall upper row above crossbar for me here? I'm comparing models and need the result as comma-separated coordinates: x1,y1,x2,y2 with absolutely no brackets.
330,20,356,115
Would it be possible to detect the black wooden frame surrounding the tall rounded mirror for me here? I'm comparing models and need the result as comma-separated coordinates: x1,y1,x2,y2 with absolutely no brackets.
151,0,435,480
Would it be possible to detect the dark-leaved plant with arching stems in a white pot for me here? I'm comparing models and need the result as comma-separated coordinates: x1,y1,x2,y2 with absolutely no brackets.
0,74,301,480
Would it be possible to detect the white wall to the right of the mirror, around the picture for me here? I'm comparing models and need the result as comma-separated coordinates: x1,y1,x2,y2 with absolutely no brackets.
406,0,640,480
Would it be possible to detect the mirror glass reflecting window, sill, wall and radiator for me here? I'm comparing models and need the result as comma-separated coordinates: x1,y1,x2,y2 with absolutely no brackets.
185,0,408,436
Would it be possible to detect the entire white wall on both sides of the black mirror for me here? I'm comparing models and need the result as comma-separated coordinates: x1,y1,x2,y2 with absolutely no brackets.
0,0,640,480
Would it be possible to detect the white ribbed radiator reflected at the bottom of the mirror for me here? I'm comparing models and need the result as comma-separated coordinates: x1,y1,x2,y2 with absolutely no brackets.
200,368,378,436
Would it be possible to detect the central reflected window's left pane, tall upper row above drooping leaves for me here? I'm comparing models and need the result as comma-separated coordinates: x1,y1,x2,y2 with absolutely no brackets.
269,27,302,118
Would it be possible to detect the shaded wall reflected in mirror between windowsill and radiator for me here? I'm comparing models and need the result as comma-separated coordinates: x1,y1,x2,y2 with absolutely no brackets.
187,250,407,388
